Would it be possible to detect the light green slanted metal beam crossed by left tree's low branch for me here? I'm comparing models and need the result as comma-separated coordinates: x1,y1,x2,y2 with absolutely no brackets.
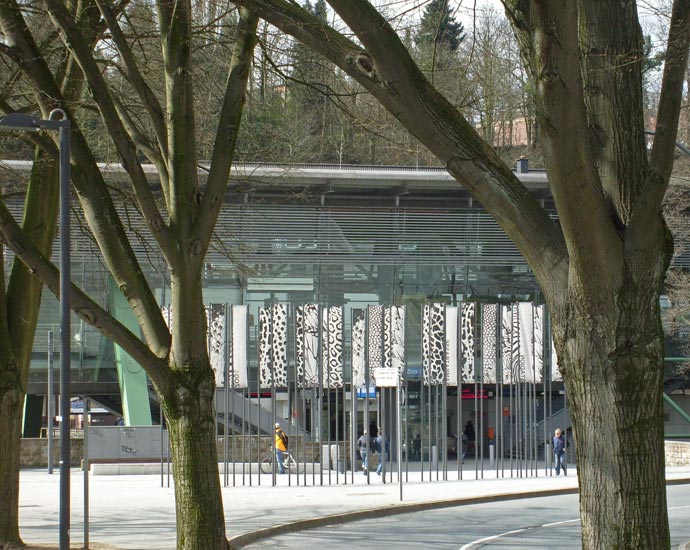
108,278,153,426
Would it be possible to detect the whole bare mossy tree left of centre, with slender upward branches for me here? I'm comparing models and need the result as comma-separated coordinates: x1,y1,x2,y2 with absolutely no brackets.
0,0,258,550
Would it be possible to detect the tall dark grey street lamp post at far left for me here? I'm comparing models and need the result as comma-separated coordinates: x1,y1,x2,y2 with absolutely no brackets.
0,109,71,550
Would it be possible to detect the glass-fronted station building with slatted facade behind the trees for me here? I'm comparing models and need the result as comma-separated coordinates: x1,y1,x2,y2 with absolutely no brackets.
5,162,690,452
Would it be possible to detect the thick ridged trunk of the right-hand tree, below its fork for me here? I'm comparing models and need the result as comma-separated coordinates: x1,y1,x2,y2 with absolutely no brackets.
557,239,670,550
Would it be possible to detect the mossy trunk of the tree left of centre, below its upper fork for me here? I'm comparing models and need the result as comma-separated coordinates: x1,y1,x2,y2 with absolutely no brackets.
159,270,227,550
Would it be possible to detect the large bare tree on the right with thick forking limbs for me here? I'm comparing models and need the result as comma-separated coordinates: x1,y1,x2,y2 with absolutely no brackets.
224,0,690,550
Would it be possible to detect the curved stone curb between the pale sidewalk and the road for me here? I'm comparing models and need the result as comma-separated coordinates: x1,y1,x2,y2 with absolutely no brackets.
228,478,690,550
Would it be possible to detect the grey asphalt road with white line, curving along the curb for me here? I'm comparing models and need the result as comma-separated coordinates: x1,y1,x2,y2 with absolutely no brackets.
245,485,690,550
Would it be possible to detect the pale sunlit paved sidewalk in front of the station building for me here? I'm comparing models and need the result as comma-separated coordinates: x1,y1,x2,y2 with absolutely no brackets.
14,468,690,550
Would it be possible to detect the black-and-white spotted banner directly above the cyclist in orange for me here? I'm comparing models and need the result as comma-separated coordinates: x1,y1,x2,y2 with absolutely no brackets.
259,304,287,388
